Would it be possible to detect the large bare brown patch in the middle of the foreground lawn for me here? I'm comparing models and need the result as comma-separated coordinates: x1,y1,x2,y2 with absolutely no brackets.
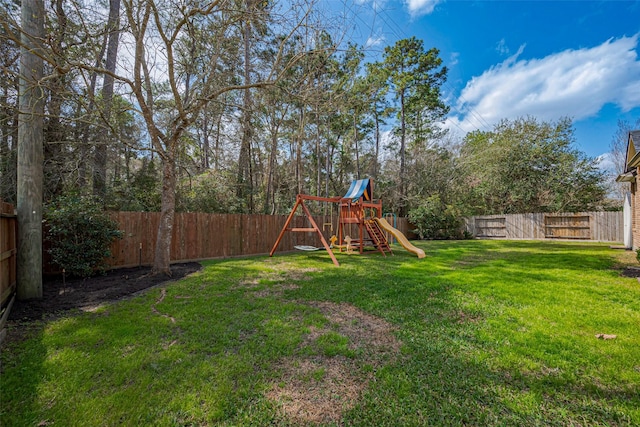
267,301,401,424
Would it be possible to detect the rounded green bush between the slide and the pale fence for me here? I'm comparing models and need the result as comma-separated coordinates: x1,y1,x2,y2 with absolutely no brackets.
409,195,462,239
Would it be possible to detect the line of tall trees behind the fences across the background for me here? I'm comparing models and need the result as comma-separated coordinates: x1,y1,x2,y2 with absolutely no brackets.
0,0,606,270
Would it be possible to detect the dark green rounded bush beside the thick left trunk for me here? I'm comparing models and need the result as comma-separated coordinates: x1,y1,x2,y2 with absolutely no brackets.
45,195,122,277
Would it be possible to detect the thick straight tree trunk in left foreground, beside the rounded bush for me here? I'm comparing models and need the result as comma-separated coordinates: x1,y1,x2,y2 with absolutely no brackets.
17,0,44,299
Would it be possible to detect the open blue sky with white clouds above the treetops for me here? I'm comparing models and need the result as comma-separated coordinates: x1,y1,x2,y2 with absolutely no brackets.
334,0,640,164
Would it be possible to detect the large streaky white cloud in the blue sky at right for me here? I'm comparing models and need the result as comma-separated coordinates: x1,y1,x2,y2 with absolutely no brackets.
447,34,640,131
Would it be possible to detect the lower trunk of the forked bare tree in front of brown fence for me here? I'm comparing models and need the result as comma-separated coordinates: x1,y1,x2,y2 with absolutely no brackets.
152,153,176,276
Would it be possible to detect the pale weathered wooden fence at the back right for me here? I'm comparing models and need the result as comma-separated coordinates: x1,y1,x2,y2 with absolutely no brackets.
465,212,624,242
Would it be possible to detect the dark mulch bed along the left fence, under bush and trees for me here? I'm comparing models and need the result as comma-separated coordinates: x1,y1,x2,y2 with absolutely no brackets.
9,262,202,321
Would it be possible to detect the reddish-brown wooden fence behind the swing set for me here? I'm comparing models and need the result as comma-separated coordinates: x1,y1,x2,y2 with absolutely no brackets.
84,212,408,272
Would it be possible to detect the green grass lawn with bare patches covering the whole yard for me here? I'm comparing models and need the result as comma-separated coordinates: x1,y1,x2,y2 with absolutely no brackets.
0,241,640,426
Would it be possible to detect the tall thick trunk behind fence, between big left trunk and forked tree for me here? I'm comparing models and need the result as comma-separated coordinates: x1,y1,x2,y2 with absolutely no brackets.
93,0,120,202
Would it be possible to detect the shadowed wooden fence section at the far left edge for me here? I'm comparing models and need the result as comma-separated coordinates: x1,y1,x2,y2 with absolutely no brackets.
0,200,18,342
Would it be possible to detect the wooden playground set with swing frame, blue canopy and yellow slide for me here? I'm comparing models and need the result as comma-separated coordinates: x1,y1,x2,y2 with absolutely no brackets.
269,178,425,266
